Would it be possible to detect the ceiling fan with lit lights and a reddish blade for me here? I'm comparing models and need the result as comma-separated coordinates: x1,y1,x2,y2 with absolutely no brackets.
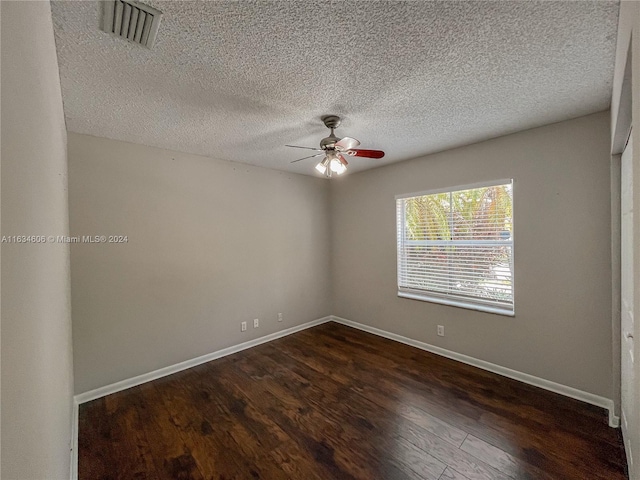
285,115,384,177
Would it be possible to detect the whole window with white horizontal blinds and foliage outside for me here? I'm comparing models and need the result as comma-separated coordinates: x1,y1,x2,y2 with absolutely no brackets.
396,180,514,315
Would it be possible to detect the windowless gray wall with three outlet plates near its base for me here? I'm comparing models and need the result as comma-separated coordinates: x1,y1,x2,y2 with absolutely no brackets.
68,133,331,393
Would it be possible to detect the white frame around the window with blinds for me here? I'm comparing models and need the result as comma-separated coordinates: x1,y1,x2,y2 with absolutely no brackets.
395,178,515,317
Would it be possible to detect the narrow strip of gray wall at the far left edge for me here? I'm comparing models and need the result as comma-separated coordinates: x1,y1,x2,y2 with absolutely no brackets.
0,2,73,480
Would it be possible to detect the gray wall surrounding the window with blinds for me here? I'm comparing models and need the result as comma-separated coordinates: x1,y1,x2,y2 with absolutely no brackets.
331,112,612,398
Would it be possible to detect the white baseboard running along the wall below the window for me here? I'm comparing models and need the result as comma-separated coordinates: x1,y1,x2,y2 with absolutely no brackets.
330,315,620,427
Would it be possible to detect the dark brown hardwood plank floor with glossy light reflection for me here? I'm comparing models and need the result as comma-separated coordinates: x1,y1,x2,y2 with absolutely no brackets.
78,323,627,480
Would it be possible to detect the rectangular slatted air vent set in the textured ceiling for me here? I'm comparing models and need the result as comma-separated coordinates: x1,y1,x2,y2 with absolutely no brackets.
102,0,162,48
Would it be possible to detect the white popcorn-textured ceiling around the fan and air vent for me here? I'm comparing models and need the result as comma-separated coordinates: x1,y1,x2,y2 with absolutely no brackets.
52,1,618,175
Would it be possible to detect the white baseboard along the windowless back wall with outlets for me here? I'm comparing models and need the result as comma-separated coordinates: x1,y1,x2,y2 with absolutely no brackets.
74,316,331,404
